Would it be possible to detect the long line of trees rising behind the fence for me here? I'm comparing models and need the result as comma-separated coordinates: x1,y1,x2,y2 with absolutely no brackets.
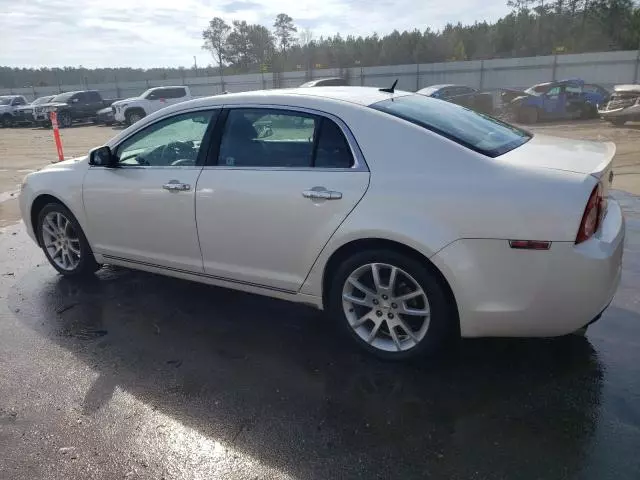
0,0,640,88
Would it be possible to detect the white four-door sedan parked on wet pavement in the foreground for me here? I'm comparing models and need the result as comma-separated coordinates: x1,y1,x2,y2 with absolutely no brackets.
20,87,625,359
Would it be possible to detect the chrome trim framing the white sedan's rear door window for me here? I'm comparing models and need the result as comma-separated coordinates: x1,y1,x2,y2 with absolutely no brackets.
212,103,369,172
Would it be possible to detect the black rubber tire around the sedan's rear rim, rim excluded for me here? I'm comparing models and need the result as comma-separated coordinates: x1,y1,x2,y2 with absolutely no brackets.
328,250,458,360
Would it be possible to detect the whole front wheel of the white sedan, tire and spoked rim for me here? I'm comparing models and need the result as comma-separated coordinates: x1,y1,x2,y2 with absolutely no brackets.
37,203,100,277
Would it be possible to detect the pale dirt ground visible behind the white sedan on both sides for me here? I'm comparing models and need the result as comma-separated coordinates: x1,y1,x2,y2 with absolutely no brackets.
0,120,640,228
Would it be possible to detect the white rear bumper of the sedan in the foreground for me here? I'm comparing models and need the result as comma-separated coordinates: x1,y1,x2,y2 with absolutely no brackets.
432,200,625,337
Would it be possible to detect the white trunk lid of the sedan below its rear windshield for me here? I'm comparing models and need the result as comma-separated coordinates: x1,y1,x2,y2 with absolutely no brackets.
498,135,616,178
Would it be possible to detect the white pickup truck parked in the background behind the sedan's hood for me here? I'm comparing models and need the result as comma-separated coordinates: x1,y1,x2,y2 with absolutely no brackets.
112,86,193,125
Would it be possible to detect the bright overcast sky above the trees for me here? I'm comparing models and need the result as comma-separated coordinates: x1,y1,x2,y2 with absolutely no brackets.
0,0,508,68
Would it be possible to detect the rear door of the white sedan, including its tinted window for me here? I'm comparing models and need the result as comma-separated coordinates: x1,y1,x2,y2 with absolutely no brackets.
196,107,369,291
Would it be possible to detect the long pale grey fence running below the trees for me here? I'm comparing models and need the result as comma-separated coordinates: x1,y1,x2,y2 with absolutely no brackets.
0,50,640,98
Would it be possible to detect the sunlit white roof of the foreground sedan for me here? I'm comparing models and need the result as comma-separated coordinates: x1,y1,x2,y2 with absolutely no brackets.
179,87,413,106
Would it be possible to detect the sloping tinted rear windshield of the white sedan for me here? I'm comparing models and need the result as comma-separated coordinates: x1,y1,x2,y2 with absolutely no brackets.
371,95,532,157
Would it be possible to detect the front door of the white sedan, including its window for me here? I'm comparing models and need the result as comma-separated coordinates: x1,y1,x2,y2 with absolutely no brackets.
83,110,217,273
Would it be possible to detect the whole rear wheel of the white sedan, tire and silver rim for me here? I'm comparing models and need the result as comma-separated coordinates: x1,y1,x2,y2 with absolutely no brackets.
328,250,457,360
